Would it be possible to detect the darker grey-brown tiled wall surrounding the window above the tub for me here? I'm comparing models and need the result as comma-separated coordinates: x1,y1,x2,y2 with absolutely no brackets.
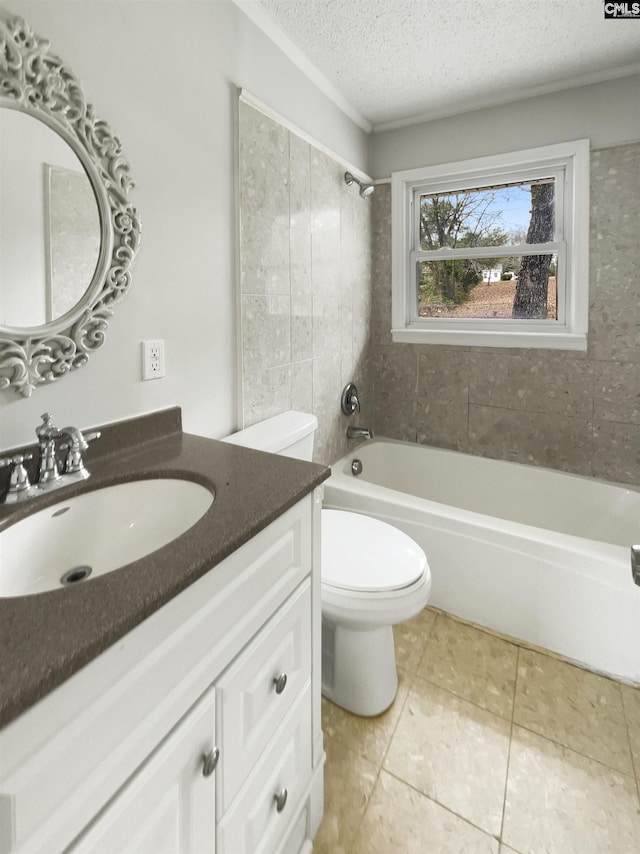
373,143,640,483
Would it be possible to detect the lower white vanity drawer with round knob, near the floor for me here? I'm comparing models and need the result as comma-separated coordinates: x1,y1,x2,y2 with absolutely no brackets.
216,683,311,854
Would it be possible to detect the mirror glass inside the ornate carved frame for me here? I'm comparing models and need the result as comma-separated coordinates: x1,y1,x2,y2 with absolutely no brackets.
0,109,100,327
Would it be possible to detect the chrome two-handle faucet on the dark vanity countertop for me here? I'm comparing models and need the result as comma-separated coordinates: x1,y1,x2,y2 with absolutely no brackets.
0,412,100,504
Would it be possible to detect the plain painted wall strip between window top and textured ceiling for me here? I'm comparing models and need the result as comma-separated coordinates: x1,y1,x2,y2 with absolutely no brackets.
369,75,640,179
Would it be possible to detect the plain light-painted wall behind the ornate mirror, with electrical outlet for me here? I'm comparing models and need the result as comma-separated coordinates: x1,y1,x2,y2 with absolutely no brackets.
0,0,367,448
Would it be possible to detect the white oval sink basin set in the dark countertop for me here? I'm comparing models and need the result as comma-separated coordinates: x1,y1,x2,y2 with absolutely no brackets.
0,478,214,597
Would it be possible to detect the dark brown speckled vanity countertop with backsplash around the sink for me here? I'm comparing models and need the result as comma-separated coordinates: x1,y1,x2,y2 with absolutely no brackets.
0,408,330,727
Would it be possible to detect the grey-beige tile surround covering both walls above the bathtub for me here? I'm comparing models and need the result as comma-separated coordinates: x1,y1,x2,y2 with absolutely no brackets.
240,110,640,483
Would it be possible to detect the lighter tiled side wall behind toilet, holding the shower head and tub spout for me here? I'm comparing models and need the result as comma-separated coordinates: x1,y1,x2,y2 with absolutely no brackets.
239,102,373,463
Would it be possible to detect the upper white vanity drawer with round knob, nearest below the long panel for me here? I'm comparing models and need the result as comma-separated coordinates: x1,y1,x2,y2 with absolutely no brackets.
217,579,311,813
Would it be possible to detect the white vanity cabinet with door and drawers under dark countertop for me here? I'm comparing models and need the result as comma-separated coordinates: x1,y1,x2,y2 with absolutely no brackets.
0,488,324,854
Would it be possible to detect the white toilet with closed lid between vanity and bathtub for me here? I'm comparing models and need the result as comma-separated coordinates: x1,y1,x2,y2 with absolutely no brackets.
225,411,431,716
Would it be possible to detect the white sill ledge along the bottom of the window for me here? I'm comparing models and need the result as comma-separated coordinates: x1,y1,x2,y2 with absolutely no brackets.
391,328,587,351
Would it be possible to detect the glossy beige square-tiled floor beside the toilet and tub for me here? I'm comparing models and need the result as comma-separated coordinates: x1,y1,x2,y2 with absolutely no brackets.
313,608,640,854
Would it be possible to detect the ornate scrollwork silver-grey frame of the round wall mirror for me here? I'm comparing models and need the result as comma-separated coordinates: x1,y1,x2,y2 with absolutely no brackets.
0,9,140,397
